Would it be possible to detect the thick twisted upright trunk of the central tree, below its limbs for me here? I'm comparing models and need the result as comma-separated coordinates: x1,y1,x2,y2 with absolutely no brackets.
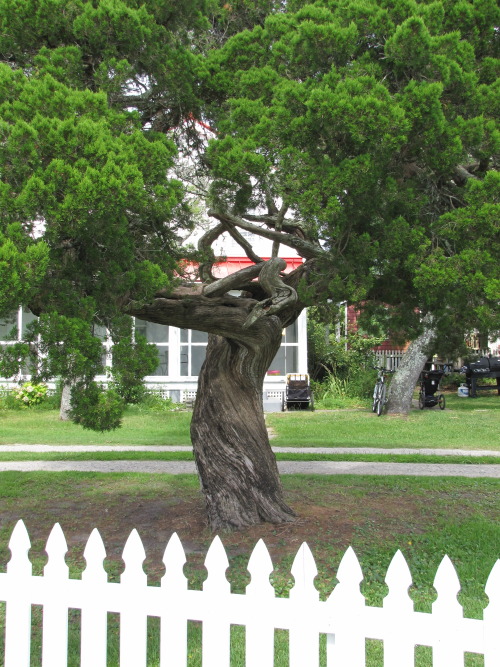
191,330,295,530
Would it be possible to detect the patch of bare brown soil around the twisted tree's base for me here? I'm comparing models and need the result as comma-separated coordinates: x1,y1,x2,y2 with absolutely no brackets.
0,480,434,581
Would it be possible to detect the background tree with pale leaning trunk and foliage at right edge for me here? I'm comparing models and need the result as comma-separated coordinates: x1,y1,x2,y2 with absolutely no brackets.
387,165,500,414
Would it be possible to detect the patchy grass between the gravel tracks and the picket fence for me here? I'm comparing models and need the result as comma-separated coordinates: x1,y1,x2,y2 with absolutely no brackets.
0,472,500,667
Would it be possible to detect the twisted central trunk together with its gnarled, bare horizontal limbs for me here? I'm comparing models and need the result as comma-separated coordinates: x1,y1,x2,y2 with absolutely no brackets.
128,258,307,530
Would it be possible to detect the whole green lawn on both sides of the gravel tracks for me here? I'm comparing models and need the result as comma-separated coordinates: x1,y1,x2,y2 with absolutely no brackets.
0,394,500,667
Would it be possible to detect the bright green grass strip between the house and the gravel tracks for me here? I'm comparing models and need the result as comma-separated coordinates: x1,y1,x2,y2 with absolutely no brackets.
0,394,500,462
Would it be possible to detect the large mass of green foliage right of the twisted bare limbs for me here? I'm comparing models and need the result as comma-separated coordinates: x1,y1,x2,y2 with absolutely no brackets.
207,0,500,339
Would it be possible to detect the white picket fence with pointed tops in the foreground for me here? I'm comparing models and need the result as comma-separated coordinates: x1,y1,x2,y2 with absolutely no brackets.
0,521,500,667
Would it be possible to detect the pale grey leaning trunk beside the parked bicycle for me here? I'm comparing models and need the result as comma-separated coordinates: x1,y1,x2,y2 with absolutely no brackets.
387,315,436,415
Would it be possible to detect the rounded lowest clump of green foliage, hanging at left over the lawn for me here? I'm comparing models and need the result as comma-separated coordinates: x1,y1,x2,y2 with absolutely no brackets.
70,382,125,431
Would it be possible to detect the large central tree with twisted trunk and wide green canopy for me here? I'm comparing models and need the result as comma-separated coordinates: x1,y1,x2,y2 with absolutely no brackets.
0,0,499,528
